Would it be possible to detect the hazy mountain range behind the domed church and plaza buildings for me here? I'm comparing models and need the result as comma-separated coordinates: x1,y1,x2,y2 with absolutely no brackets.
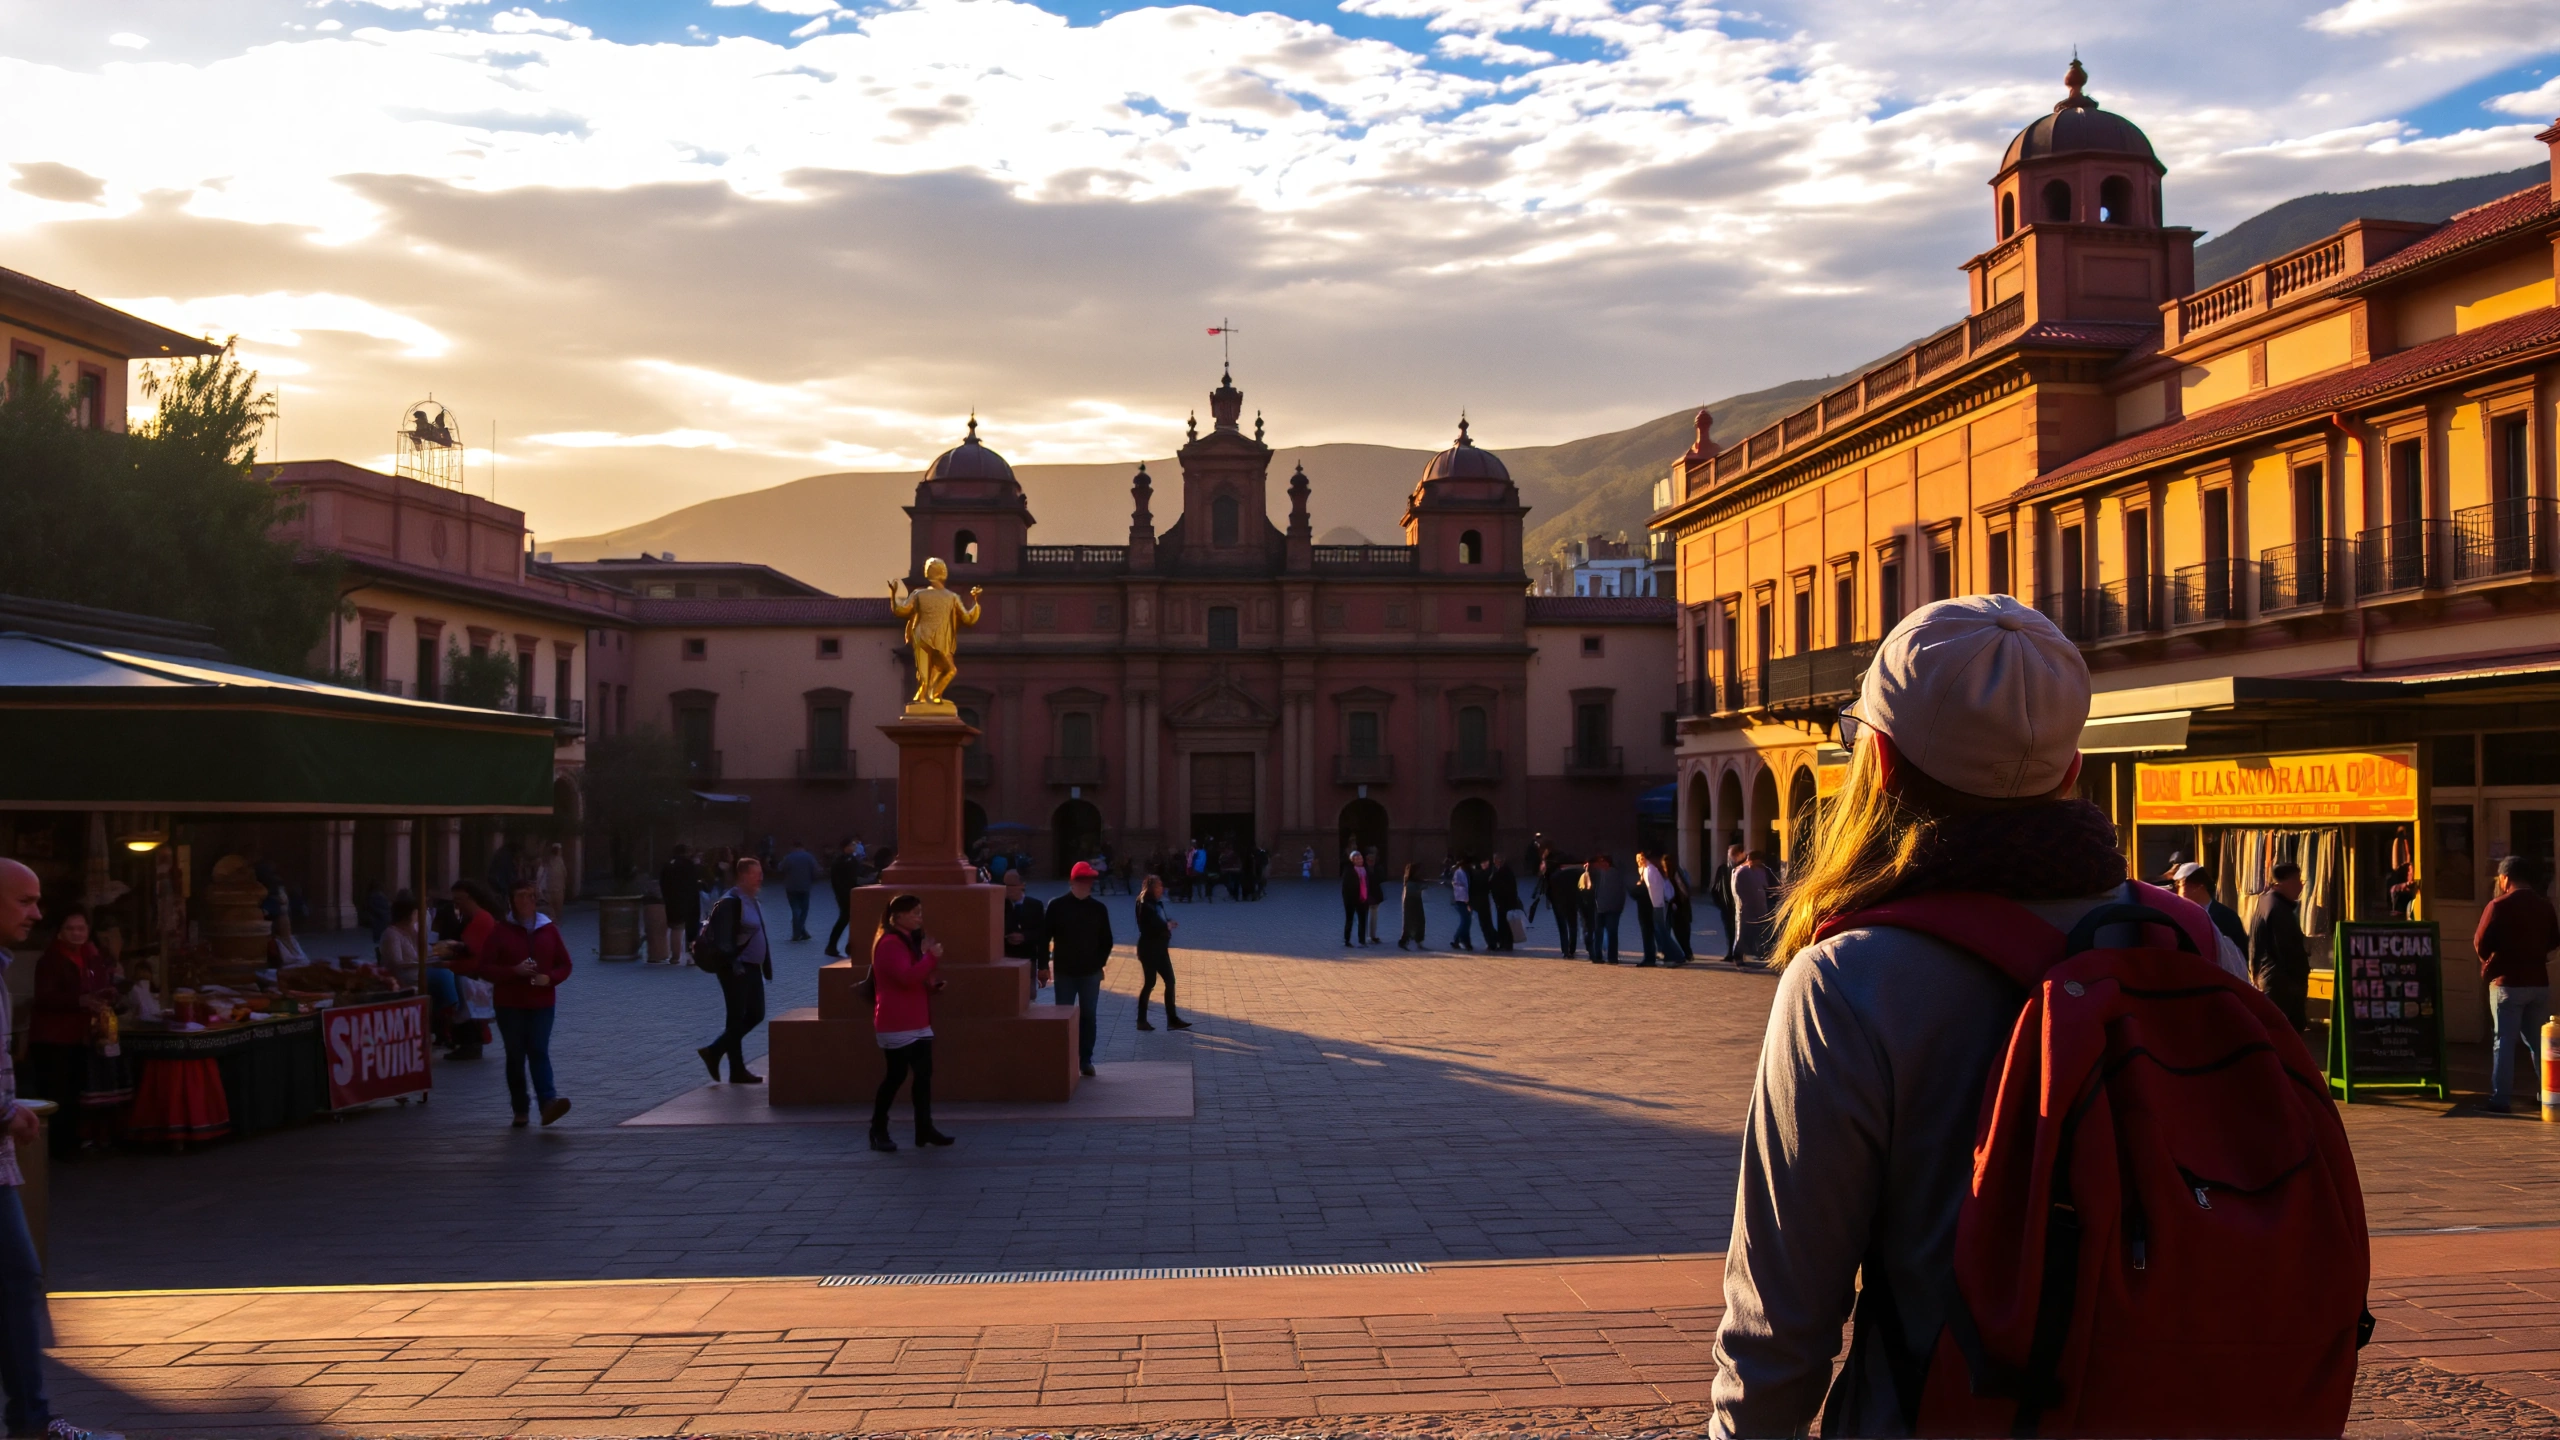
543,167,2545,594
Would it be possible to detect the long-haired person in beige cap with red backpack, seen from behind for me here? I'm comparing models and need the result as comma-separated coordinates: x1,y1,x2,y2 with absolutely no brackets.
1710,594,2368,1437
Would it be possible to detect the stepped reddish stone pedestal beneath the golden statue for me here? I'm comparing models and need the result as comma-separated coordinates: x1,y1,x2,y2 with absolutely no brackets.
765,712,1078,1104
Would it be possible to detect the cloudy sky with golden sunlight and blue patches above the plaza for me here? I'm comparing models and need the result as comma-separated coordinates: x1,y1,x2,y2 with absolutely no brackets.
0,0,2560,538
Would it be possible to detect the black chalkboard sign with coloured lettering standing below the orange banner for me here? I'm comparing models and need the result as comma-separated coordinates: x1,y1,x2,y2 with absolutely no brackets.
2330,922,2445,1104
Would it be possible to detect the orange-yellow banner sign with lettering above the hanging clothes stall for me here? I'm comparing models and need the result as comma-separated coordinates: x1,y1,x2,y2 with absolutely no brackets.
2132,746,2417,825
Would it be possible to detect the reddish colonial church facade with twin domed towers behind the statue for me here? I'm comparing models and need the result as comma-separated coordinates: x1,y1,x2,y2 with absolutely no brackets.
909,363,1533,874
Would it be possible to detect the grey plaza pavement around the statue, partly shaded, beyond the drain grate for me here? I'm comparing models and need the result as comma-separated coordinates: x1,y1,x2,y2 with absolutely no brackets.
51,881,2560,1289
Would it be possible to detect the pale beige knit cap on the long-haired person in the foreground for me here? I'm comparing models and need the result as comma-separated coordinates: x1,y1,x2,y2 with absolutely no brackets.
1859,594,2089,799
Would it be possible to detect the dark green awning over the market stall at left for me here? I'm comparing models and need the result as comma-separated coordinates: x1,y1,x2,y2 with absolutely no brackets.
0,630,556,815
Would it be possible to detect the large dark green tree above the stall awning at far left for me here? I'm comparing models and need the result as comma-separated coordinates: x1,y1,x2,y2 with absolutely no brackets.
0,346,340,674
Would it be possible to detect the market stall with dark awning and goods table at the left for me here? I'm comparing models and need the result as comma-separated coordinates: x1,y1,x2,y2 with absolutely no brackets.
0,630,553,1143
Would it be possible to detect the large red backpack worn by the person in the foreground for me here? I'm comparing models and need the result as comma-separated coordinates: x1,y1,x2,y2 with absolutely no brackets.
1823,884,2373,1437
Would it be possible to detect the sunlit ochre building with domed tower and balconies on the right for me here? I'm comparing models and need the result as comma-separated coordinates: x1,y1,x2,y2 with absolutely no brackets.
1651,61,2560,1040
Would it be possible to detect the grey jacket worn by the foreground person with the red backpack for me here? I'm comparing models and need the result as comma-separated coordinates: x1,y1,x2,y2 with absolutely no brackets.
1710,892,2130,1437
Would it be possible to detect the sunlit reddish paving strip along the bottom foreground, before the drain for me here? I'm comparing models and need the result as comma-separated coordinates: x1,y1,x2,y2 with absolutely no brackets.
54,1230,2560,1437
